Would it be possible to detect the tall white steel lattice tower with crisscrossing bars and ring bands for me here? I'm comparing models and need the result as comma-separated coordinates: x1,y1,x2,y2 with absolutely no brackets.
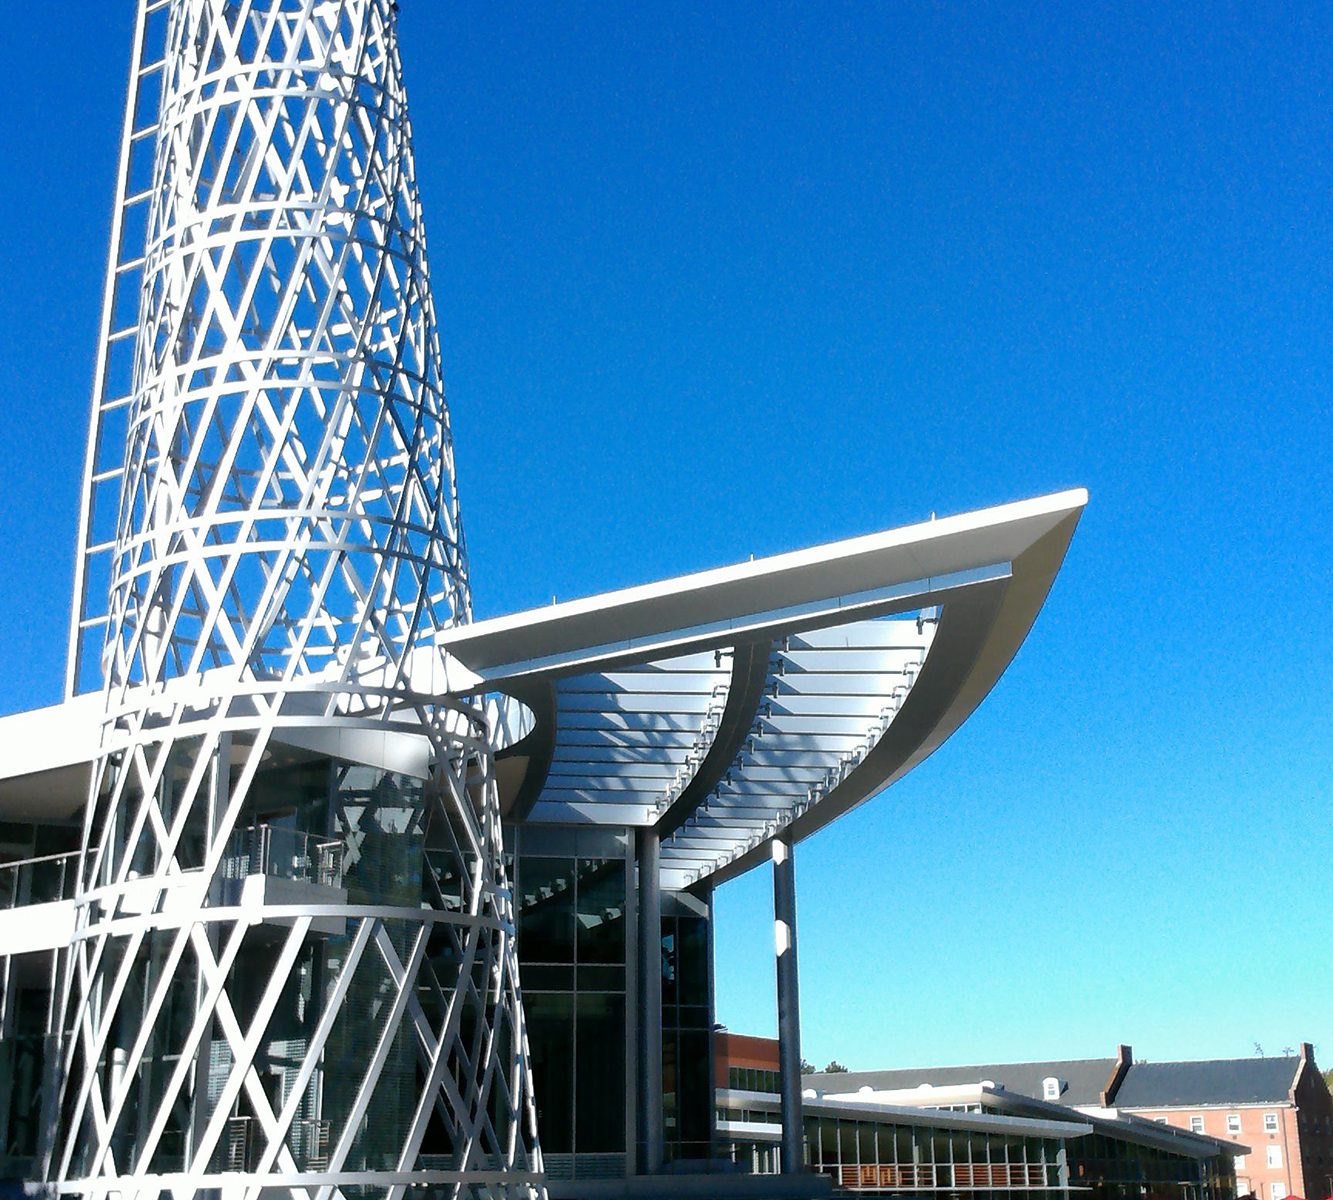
48,0,541,1200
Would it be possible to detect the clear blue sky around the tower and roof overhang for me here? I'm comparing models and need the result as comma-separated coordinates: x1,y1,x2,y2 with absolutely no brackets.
0,0,1333,1067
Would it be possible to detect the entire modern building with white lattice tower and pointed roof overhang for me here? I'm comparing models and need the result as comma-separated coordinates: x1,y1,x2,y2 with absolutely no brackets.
0,0,1086,1200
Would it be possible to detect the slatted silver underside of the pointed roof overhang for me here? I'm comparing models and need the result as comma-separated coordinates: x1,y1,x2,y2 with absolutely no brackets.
527,613,936,887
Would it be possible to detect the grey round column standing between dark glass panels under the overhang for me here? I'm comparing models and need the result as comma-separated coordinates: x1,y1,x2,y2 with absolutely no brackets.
639,828,665,1175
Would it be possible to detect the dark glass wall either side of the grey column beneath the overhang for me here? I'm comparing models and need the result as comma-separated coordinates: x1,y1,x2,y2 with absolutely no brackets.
507,825,713,1180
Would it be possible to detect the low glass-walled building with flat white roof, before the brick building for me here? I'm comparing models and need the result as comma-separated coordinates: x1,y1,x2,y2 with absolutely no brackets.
717,1033,1236,1200
